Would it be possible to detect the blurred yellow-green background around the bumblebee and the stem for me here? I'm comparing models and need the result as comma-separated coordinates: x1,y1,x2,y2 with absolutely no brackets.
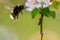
0,0,60,40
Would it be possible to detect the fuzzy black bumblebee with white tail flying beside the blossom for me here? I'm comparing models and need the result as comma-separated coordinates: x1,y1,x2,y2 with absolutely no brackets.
10,5,24,20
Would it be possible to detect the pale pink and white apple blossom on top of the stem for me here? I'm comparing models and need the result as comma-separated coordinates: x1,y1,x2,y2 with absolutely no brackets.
25,0,52,11
